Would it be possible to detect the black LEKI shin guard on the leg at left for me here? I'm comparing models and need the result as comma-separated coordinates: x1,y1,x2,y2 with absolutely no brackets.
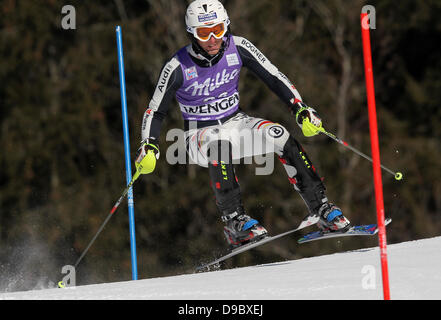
207,140,241,213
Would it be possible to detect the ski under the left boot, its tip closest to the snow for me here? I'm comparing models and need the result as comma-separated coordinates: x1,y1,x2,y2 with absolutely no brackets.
196,215,319,272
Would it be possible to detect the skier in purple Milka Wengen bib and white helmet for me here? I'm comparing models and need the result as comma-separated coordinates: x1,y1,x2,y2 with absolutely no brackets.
135,0,349,247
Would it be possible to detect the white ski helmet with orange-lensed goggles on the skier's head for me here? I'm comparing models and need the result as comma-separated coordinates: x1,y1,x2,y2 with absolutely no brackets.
185,0,230,41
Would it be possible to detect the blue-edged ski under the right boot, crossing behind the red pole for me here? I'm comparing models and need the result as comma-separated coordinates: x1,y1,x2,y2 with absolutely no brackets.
297,218,392,243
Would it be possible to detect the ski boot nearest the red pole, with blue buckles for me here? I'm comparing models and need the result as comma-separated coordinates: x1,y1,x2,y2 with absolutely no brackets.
317,203,350,232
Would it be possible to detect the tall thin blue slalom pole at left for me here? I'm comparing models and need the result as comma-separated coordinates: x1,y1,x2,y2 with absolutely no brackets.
115,26,138,280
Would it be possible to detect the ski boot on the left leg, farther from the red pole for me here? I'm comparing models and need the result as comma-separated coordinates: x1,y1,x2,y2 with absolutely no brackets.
222,207,268,249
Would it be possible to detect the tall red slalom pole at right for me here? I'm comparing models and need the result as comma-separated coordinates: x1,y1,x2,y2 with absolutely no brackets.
361,13,390,300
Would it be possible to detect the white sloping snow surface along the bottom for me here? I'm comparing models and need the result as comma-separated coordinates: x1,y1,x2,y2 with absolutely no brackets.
0,237,441,300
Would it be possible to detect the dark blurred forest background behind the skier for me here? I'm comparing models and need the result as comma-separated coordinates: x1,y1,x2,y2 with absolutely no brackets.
0,0,441,291
